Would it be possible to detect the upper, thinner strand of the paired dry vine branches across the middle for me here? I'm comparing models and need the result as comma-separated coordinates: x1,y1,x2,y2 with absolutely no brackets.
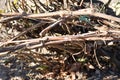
0,30,120,45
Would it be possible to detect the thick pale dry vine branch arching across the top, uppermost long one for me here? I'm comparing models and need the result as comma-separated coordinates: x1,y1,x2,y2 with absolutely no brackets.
0,8,120,22
